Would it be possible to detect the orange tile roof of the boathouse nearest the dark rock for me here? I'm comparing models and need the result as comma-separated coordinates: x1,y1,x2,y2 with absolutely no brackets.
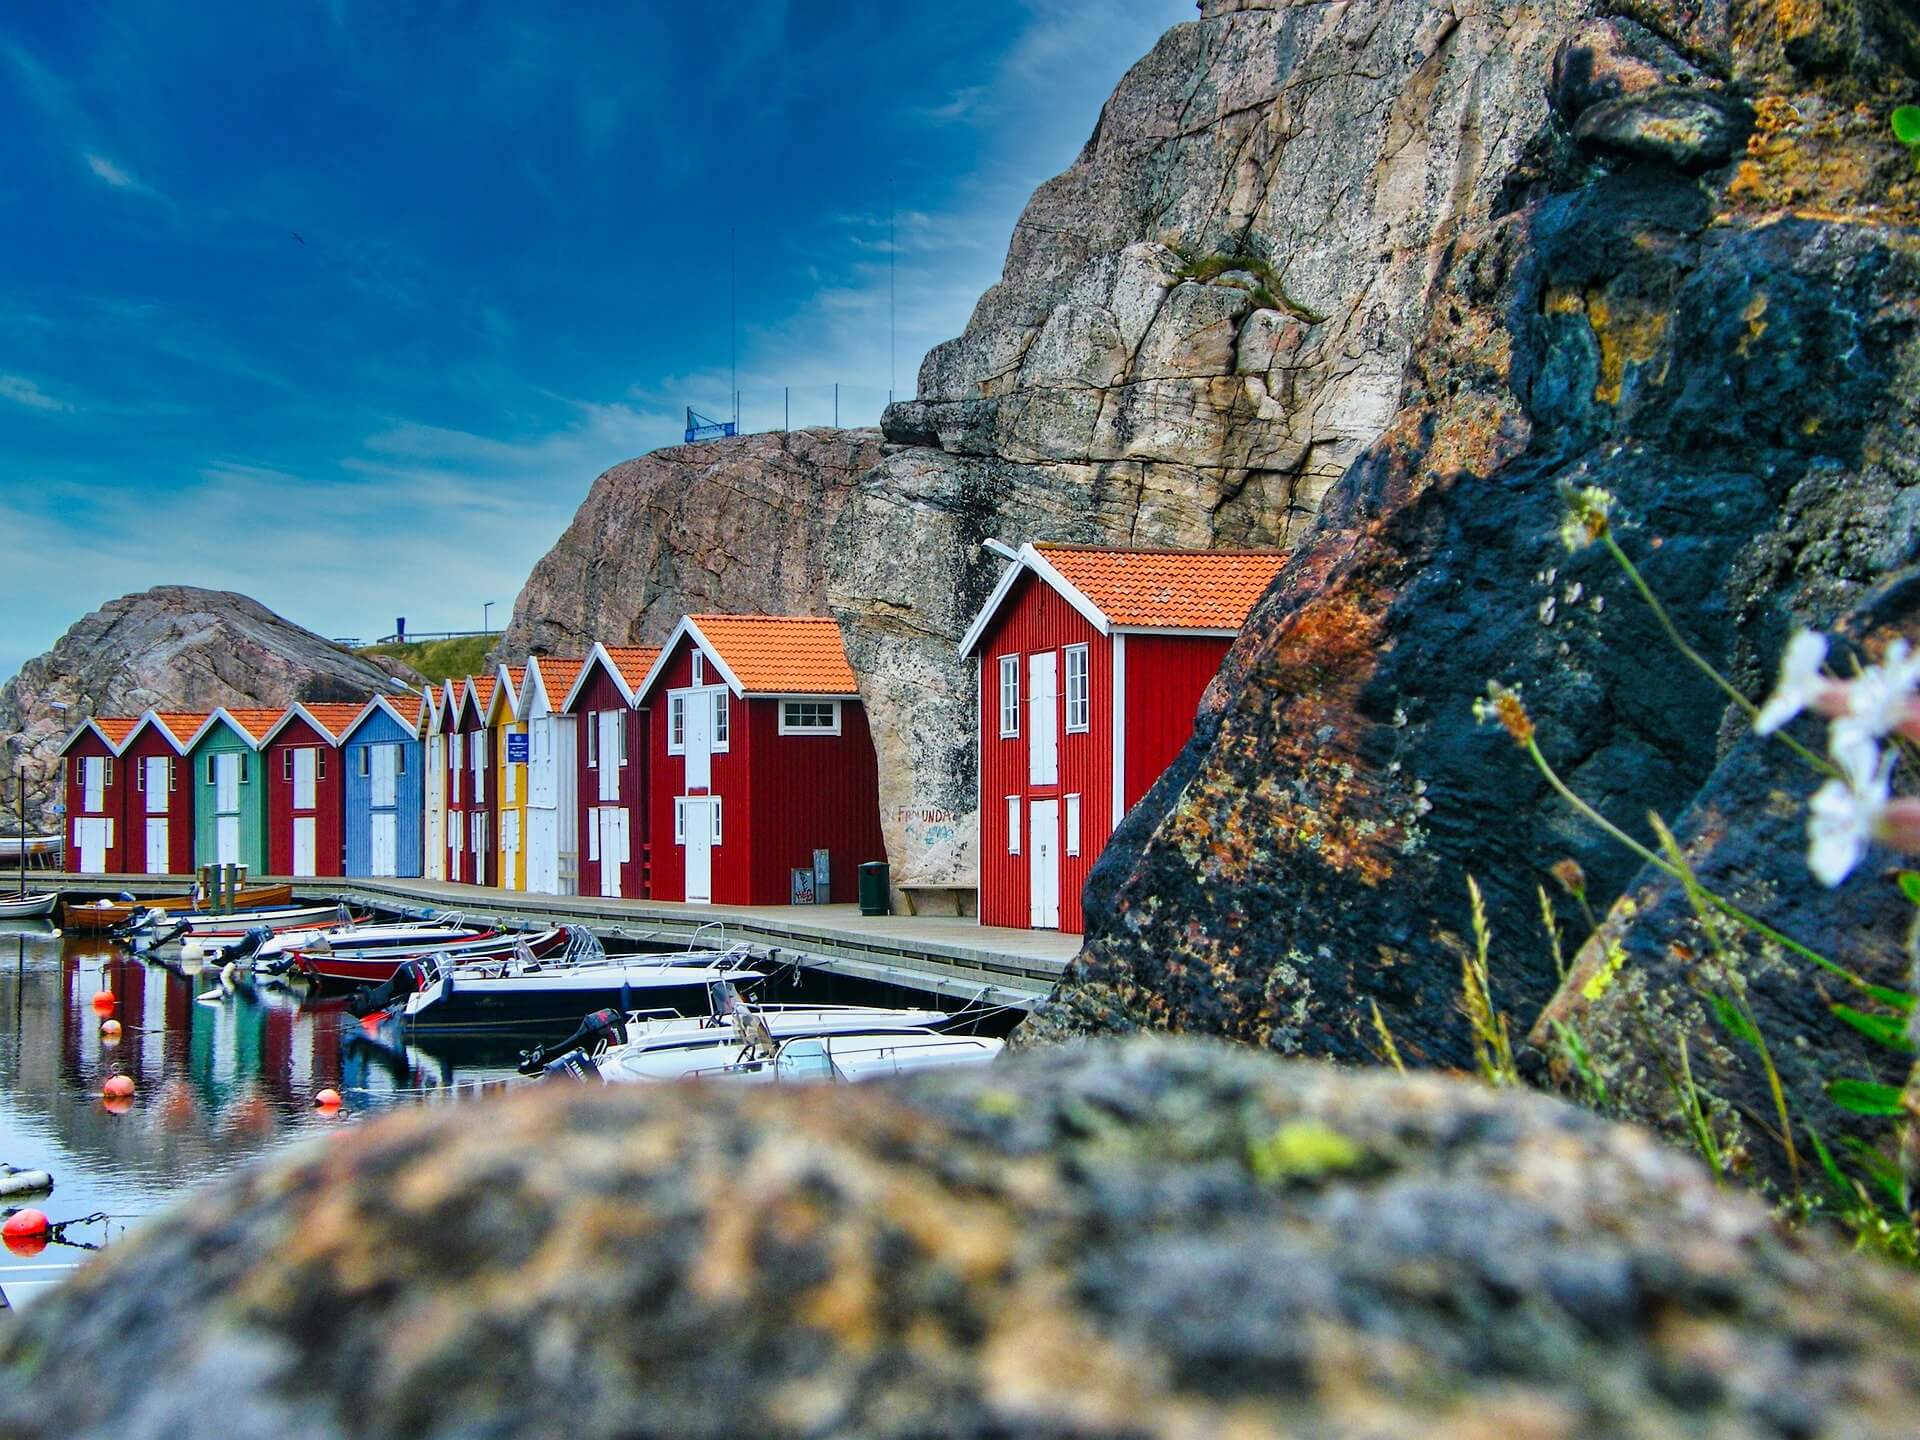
1033,545,1286,630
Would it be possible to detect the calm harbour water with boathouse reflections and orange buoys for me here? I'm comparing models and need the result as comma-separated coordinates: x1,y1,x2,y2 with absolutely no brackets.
0,922,515,1306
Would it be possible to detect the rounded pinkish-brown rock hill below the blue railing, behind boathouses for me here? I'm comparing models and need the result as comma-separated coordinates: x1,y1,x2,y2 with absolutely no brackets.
499,430,883,659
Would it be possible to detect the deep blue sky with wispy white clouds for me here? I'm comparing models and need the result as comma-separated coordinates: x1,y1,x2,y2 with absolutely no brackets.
0,0,1192,678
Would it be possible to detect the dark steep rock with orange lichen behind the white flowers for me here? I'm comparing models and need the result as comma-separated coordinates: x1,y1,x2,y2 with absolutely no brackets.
1031,4,1920,1098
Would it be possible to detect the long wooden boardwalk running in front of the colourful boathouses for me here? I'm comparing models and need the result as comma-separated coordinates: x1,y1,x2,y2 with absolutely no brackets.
48,876,1081,1010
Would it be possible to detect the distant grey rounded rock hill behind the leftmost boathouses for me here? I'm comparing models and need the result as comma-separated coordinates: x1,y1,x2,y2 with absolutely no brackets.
0,586,417,814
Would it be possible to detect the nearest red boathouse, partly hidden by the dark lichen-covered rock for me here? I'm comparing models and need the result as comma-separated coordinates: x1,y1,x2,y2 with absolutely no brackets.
960,545,1284,933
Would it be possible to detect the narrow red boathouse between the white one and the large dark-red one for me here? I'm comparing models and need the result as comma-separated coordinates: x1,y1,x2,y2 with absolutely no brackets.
559,645,660,900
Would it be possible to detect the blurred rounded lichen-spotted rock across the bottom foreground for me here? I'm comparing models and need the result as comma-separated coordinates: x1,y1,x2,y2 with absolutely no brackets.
0,1041,1920,1440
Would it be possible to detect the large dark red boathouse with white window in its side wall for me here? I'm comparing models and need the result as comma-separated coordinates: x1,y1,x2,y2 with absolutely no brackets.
636,614,885,904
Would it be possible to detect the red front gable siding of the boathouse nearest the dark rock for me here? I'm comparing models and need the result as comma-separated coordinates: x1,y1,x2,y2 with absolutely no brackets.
979,574,1114,933
